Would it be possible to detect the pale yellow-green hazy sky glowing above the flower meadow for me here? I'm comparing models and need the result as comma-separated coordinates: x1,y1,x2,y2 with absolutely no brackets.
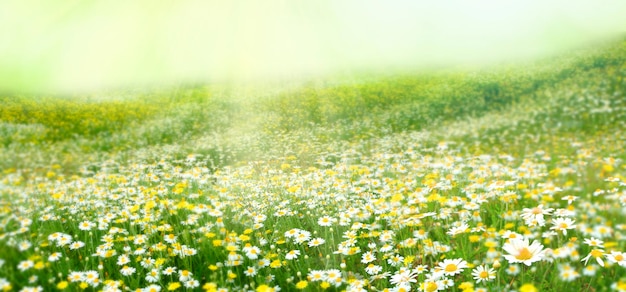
0,0,626,92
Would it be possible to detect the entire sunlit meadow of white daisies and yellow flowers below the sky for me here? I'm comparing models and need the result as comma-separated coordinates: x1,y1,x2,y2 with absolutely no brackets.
0,40,626,292
